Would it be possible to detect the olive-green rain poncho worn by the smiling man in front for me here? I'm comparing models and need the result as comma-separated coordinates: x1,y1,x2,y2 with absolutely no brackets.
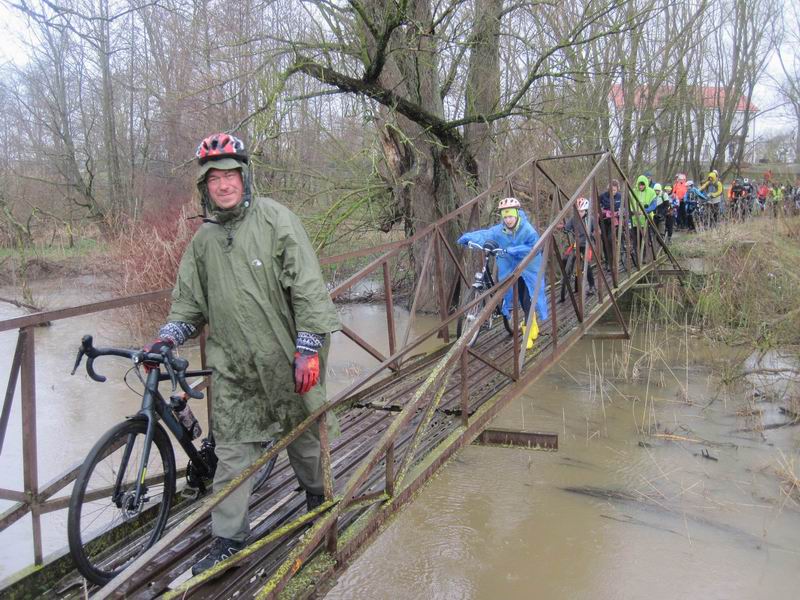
168,195,340,443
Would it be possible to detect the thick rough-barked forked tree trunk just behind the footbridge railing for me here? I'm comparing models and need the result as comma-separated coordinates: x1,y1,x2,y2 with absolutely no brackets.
372,0,502,311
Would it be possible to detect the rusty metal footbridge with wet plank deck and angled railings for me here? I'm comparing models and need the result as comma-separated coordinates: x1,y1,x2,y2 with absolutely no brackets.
0,152,685,598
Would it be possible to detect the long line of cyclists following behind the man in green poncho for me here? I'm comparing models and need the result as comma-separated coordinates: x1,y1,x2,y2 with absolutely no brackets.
458,169,800,349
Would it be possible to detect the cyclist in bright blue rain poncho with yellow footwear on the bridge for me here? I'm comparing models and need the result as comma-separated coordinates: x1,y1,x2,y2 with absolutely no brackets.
458,198,548,349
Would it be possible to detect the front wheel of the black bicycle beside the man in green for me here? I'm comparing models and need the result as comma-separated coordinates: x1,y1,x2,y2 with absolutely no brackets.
67,419,175,585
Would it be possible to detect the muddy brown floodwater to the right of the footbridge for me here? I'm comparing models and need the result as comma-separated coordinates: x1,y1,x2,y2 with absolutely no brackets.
326,330,800,600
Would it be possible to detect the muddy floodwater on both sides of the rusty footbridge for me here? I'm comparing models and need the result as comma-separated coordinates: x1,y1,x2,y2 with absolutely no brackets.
0,278,800,599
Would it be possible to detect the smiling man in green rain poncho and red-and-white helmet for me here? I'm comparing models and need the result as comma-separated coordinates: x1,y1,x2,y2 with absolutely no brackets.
149,133,340,575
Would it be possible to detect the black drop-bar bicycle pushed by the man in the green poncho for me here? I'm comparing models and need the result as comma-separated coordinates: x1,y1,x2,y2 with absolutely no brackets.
67,335,275,585
